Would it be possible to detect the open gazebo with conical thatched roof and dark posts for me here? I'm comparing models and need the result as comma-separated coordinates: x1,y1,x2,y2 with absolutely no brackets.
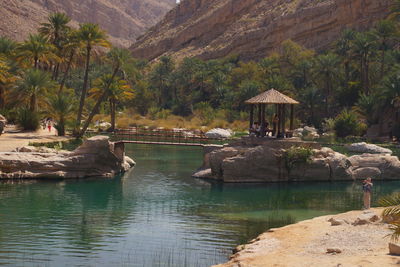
245,89,299,137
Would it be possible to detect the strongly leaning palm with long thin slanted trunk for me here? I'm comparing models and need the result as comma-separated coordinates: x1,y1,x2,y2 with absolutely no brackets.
78,48,133,137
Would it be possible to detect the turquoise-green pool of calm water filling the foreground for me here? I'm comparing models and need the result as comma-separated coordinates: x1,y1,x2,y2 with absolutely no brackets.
0,145,400,266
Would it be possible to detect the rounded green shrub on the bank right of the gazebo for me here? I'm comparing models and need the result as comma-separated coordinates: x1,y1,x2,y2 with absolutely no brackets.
334,110,367,138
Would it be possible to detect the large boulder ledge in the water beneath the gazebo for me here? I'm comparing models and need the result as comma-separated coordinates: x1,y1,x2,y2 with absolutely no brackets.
193,138,400,182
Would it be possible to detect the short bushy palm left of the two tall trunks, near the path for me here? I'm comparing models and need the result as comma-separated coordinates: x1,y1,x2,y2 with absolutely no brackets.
47,93,75,136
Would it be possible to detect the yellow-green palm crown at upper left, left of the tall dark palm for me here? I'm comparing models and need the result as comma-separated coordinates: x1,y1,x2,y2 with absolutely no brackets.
18,34,59,69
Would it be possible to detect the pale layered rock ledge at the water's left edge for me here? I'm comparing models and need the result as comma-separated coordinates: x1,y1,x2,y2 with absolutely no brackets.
0,136,135,179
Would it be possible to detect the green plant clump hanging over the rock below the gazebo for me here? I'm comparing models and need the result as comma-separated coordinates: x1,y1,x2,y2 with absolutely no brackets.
282,146,313,175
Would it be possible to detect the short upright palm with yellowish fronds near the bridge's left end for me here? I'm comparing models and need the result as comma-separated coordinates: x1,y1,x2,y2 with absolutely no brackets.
90,75,134,131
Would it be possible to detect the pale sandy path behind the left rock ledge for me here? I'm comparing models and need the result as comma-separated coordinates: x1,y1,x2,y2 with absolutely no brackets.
0,126,69,152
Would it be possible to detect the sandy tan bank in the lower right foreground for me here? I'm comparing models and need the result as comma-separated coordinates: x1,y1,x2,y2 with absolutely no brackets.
218,209,400,267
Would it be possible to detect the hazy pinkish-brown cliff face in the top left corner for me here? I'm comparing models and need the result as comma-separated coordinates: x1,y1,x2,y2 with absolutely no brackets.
0,0,175,46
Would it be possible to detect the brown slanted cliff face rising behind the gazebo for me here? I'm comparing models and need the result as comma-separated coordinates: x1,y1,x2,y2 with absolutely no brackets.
131,0,391,60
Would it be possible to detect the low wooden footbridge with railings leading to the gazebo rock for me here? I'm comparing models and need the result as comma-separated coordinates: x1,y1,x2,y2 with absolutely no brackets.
87,127,227,147
